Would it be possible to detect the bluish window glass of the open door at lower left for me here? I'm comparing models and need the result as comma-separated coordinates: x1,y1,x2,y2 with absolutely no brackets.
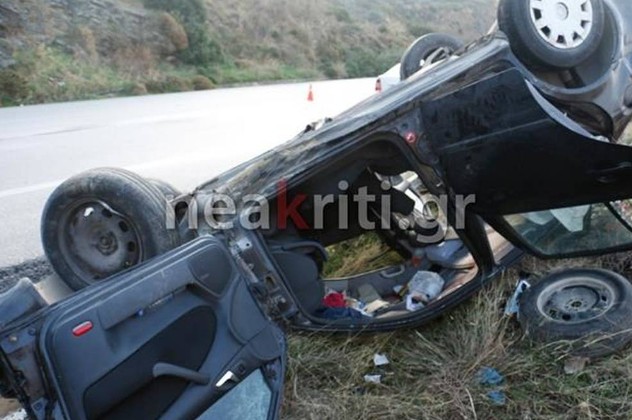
198,369,272,420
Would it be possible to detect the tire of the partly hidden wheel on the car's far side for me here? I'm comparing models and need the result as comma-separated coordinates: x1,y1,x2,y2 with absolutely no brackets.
399,33,463,80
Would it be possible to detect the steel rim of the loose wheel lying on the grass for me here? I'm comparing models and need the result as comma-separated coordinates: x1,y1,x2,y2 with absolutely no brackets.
537,277,617,324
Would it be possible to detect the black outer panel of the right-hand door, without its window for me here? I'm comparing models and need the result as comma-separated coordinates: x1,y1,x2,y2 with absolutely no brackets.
422,70,632,215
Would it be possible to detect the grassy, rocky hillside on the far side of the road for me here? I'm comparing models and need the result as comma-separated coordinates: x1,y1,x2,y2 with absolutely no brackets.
0,0,495,105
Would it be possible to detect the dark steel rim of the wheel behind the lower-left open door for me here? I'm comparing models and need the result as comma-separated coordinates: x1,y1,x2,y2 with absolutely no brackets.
59,200,143,283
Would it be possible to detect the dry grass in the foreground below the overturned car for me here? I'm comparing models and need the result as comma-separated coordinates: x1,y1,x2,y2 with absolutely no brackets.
283,241,632,419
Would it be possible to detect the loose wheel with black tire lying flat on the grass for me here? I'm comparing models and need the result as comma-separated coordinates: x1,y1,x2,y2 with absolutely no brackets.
518,269,632,357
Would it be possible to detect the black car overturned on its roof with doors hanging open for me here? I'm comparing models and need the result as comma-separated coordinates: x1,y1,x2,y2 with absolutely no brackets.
0,0,632,419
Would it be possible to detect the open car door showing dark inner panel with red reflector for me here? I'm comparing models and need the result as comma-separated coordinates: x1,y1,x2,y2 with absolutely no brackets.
1,237,285,420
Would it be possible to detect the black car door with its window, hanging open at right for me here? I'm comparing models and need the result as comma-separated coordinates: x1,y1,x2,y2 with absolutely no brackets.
421,68,632,257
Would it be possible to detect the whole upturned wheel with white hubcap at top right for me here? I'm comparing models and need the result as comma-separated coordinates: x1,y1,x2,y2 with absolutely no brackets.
498,0,606,69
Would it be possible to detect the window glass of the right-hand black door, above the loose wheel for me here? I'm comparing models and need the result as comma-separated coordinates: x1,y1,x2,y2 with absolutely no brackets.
505,200,632,256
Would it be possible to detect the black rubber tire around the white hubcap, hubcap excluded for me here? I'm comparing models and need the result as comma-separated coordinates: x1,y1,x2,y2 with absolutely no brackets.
498,0,606,70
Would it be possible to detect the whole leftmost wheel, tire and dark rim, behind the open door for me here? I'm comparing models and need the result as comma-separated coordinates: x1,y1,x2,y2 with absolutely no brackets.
41,168,180,290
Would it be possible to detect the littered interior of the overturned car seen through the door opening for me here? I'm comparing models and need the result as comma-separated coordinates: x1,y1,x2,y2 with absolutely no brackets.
262,140,513,324
